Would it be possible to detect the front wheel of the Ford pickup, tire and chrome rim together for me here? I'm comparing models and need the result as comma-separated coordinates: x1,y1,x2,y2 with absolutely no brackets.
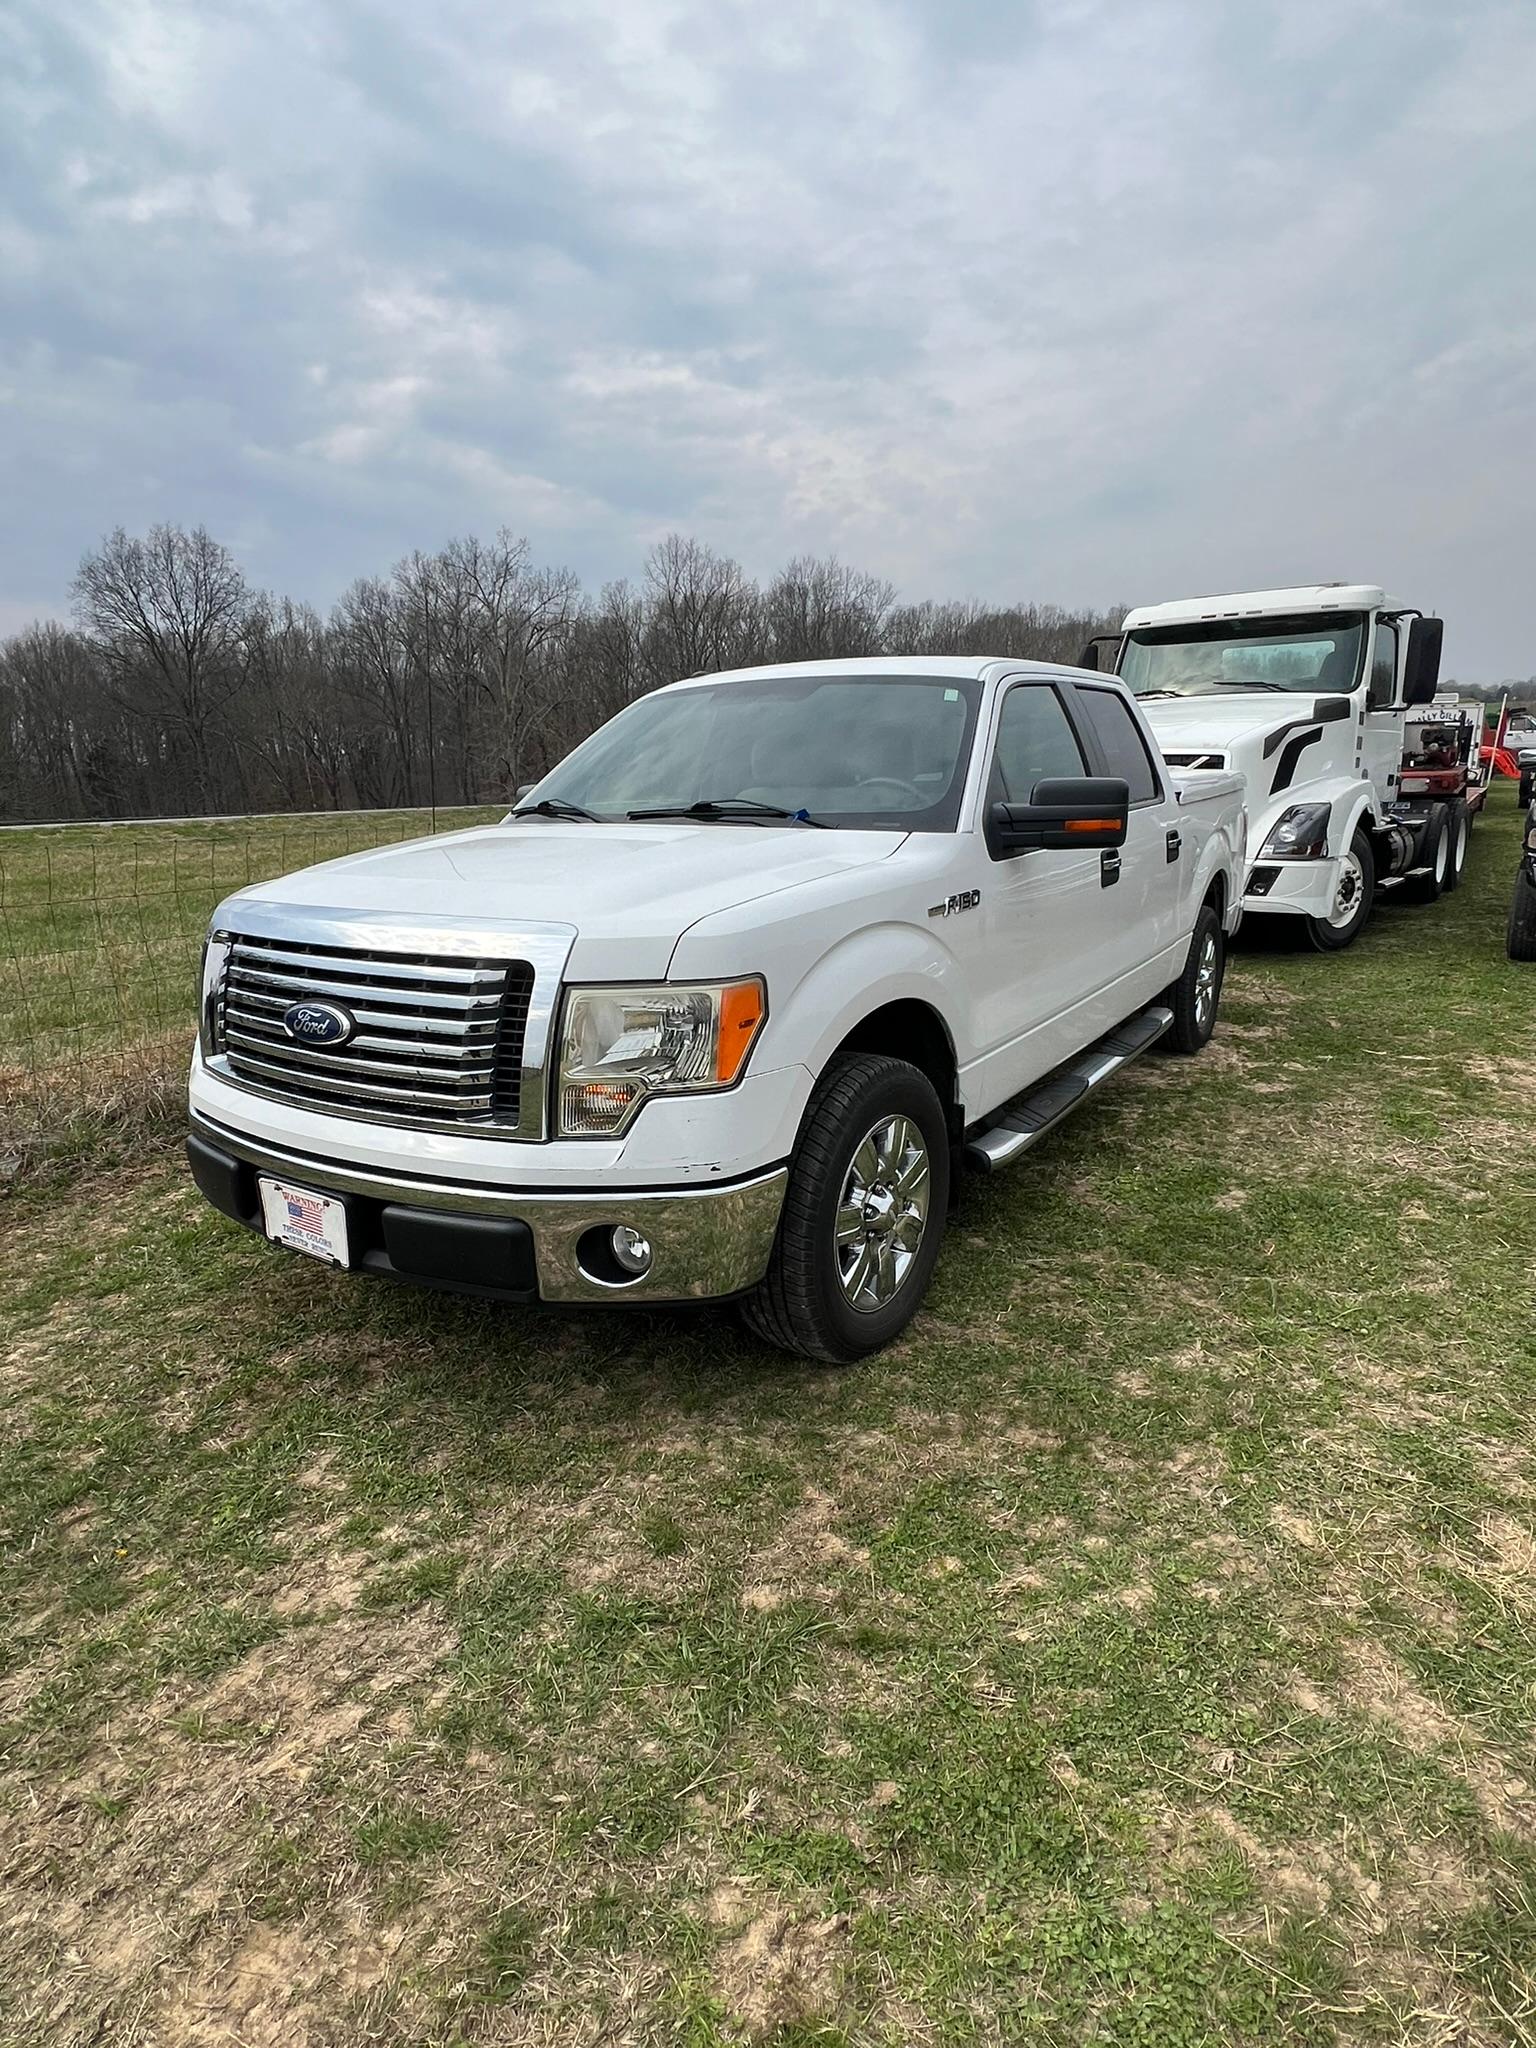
741,1053,950,1366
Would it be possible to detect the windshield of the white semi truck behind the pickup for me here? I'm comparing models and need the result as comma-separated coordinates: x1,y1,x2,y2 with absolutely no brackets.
1120,612,1366,696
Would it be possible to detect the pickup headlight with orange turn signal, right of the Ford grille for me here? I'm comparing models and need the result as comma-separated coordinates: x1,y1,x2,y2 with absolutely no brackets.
555,975,768,1139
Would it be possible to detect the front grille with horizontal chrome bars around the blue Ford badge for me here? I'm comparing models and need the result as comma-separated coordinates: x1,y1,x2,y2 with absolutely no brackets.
217,936,532,1135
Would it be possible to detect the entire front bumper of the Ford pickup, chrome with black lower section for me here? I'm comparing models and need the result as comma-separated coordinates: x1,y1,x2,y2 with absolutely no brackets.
186,1114,788,1303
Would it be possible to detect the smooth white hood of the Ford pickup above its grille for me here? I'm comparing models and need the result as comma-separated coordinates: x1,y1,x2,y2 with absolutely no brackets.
221,819,907,979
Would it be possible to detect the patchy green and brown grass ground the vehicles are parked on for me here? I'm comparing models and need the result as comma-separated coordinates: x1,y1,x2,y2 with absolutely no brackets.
0,791,1536,2048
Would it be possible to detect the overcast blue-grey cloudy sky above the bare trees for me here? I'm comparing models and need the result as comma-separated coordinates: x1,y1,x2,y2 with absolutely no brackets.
0,0,1536,680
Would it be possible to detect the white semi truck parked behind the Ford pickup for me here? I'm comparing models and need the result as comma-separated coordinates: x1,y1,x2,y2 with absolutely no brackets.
1083,584,1483,950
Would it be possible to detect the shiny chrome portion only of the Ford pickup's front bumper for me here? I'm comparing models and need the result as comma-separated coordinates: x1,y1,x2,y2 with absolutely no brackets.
193,1112,788,1303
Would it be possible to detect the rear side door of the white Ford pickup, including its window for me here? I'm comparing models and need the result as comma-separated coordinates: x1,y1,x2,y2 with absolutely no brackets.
1073,682,1194,983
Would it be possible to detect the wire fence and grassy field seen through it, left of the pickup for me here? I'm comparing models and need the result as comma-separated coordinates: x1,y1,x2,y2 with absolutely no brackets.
0,809,500,1178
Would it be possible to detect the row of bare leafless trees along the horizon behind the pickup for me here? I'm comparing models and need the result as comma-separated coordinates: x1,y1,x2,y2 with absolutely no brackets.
0,526,1118,821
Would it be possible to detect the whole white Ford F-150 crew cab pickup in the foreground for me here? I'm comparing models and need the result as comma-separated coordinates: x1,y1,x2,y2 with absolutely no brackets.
188,657,1243,1362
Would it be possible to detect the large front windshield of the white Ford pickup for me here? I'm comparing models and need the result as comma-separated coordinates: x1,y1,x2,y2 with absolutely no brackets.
518,676,981,831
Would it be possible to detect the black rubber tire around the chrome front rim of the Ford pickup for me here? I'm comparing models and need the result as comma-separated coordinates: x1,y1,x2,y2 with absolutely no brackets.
741,1053,950,1366
